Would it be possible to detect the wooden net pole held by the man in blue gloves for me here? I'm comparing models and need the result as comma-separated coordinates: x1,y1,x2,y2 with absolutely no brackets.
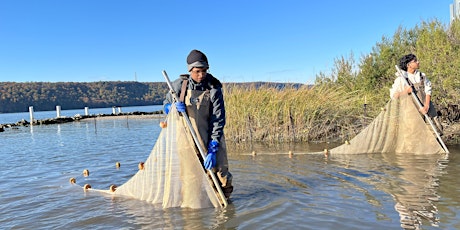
163,70,228,207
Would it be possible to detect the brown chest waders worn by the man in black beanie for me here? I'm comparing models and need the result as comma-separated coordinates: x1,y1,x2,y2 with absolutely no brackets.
179,80,233,198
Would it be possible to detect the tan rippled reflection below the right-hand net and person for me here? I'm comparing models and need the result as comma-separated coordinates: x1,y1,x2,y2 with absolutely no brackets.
331,153,448,229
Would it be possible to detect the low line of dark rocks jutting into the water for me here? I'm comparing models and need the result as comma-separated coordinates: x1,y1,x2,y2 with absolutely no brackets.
0,111,164,132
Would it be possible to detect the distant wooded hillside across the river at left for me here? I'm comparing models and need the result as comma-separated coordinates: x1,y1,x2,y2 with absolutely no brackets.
0,81,168,113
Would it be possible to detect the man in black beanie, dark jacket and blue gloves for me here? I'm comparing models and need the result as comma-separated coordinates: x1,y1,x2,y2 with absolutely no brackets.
163,50,233,198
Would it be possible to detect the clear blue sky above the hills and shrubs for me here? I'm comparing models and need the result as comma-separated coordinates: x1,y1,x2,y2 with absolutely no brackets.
0,0,453,83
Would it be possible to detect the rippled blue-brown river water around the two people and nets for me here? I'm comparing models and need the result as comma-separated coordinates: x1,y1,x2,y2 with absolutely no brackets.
0,106,460,229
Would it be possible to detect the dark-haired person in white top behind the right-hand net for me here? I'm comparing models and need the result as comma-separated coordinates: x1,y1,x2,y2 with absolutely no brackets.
390,54,443,135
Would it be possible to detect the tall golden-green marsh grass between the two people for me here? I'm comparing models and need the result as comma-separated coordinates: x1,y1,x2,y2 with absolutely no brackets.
224,82,375,143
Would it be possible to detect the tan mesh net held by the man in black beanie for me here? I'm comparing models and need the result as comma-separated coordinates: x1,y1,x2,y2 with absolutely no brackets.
110,106,220,208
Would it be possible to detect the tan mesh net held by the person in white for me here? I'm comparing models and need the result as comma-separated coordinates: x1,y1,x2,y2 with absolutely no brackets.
330,95,445,154
